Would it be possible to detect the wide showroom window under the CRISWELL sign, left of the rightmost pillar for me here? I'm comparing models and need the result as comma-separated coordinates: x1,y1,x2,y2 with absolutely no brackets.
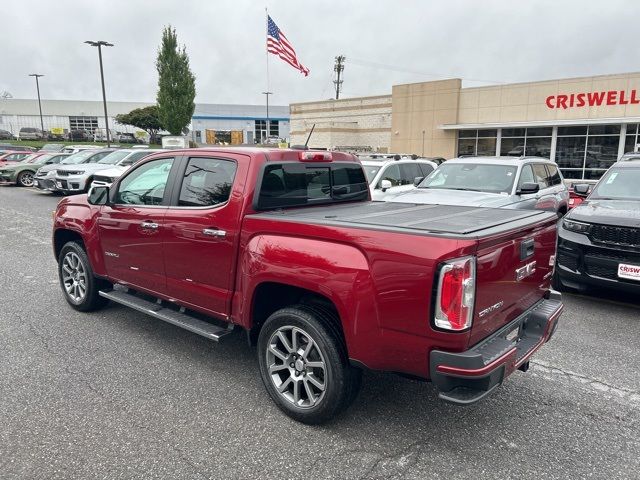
555,125,620,179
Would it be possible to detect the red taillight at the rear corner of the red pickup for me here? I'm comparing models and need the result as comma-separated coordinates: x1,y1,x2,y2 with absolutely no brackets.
434,257,476,332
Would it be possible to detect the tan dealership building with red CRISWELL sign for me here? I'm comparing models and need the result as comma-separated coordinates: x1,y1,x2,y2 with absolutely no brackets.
290,73,640,179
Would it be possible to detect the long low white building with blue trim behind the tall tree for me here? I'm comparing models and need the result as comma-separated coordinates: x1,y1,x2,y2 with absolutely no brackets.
0,98,289,144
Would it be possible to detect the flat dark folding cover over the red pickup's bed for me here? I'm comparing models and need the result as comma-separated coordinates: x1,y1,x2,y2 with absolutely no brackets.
249,202,557,239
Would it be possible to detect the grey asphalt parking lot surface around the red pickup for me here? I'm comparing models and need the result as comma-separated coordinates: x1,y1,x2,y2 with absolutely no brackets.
0,187,640,480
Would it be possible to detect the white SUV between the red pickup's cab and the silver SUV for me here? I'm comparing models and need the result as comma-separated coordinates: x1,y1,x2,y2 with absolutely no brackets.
359,155,443,201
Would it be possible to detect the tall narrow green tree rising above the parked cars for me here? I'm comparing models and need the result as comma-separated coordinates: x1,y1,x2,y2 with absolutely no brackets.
156,26,196,135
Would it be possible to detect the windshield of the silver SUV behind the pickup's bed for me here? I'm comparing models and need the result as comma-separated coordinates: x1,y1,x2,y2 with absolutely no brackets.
418,163,517,193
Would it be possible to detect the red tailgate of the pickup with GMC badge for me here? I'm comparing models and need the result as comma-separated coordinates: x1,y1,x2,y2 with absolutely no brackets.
469,214,557,345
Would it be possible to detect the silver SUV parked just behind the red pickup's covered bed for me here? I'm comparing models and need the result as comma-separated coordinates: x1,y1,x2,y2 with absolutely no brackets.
385,157,569,216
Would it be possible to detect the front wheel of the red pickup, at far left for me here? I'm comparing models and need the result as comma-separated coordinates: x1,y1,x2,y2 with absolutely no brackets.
58,242,109,312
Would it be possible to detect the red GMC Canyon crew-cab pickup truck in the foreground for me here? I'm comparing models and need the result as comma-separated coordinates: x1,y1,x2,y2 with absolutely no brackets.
53,148,563,423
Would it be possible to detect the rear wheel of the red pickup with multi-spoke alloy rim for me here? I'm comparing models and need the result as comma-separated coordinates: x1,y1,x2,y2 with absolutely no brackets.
258,305,361,424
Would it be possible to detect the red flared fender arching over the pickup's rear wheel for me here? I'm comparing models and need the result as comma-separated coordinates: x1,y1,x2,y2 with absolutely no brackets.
237,235,380,359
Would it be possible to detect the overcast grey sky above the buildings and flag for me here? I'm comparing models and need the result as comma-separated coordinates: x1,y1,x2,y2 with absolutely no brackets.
5,0,640,105
